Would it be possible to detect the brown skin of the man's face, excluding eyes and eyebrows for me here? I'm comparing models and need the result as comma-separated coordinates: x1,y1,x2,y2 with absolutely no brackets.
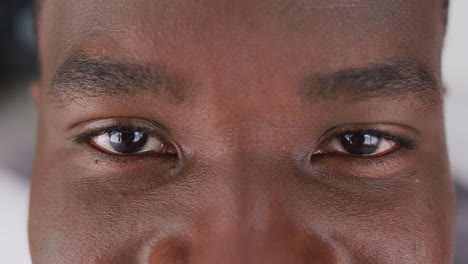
29,0,453,264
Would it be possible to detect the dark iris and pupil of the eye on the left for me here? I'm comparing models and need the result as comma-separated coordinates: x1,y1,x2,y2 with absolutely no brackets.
109,131,148,154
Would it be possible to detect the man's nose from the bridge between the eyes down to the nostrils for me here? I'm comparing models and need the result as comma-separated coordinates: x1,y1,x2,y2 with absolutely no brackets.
149,124,337,264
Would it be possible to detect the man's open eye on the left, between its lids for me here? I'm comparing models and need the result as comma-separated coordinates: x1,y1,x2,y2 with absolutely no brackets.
89,128,176,155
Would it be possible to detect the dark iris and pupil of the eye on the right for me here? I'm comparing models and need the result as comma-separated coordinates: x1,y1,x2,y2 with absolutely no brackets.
340,133,381,155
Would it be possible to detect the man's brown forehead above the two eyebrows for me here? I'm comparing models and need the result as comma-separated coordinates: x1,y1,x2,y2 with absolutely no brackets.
39,0,442,85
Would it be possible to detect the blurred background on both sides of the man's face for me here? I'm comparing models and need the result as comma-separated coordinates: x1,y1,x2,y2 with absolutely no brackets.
0,0,468,264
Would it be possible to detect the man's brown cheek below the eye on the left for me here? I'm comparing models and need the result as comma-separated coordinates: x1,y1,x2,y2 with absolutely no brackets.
29,158,230,263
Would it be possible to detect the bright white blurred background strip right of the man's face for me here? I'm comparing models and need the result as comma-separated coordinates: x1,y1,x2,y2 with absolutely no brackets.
442,0,468,186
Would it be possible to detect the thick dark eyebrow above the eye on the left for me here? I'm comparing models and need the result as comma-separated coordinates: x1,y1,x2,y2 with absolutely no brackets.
48,53,184,104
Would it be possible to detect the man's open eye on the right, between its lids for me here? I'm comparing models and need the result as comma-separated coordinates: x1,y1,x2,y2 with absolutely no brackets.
314,131,403,157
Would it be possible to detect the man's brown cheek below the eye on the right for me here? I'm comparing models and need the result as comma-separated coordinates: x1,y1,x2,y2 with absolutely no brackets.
283,168,453,263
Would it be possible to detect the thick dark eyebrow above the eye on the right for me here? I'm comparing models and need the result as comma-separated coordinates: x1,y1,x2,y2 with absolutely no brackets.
300,61,443,106
